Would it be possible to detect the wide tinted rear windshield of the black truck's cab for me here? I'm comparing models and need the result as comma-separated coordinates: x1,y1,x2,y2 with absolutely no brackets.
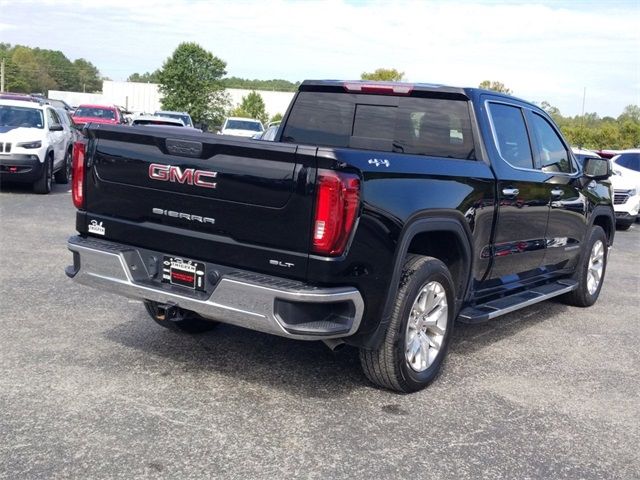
283,92,475,159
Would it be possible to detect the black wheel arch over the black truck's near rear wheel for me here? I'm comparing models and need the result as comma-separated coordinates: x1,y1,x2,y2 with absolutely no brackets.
362,210,473,348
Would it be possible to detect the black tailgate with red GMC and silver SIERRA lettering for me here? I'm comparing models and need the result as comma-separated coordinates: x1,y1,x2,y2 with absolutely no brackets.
78,125,316,278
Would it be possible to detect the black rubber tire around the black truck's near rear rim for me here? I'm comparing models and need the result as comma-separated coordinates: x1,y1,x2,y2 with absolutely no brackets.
360,255,455,392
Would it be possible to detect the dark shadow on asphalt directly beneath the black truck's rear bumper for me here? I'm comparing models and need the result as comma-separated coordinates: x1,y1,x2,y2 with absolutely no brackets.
104,314,373,398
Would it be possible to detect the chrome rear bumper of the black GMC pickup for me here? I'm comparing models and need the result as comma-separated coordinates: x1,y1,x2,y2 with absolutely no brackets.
66,236,364,340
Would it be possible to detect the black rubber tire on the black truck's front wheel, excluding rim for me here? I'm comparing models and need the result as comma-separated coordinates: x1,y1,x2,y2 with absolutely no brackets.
562,225,609,307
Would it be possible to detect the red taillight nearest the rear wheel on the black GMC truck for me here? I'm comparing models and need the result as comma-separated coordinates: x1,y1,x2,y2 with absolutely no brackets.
312,170,360,255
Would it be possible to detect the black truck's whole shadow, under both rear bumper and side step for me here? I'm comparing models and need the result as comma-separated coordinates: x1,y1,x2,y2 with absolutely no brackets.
104,302,570,398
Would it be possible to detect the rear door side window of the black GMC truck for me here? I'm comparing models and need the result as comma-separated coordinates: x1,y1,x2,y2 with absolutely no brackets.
489,103,533,169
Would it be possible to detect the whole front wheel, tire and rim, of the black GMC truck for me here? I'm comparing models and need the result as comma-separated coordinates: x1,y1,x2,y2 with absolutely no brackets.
564,225,608,307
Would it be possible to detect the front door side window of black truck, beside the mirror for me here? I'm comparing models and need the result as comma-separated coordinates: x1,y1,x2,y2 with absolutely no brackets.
530,112,572,173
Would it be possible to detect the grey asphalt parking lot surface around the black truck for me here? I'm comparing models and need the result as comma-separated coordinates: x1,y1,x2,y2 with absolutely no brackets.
0,185,640,479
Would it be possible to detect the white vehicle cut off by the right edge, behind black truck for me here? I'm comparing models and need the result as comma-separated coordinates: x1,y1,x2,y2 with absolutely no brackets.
611,149,640,230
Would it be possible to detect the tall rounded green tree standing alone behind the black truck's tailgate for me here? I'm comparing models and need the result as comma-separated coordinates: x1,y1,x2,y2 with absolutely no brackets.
158,43,229,125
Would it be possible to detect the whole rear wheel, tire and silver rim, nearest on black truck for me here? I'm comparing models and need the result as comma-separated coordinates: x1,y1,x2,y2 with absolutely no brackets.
360,255,455,392
